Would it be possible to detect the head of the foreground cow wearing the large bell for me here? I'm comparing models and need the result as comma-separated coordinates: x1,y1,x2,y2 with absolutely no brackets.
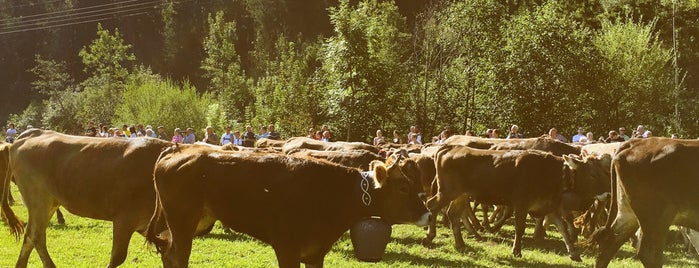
370,160,429,226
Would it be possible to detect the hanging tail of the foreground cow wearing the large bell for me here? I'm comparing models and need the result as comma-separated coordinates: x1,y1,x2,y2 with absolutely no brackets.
145,144,178,254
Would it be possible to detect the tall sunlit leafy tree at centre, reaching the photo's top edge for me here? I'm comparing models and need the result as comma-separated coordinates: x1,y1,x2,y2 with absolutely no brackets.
323,0,410,140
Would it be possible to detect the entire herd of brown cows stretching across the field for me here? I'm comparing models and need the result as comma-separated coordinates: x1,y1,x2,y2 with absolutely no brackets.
0,129,699,267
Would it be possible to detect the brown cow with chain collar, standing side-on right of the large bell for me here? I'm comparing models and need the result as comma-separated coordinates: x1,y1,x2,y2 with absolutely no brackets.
427,145,581,261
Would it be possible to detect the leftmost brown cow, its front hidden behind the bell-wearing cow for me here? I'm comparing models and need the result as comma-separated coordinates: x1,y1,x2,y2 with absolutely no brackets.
2,129,200,267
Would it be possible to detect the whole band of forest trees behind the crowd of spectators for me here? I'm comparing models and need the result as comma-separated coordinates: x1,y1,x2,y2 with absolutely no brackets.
0,0,699,141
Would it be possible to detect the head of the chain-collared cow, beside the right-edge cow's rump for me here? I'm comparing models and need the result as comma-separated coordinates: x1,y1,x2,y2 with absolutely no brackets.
563,154,612,199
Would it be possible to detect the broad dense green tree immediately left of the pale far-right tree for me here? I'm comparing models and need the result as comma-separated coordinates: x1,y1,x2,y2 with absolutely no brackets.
498,1,603,136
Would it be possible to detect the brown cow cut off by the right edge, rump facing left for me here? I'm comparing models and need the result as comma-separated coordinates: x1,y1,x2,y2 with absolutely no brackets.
589,138,699,267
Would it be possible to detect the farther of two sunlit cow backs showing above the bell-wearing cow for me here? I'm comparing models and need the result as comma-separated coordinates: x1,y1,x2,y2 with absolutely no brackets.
282,137,379,154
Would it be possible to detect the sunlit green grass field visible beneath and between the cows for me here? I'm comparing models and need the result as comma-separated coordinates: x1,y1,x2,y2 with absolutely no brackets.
0,186,699,267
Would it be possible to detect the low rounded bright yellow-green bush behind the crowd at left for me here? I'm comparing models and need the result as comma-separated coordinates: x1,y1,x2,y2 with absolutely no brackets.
111,67,211,135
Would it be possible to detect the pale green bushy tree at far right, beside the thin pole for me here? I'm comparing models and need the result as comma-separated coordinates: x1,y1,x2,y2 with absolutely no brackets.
594,18,675,135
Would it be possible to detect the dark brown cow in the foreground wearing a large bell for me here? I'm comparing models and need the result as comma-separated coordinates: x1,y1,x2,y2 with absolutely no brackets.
147,145,429,267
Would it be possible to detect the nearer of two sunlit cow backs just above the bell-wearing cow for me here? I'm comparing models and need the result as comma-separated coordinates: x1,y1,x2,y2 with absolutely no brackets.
291,150,383,170
